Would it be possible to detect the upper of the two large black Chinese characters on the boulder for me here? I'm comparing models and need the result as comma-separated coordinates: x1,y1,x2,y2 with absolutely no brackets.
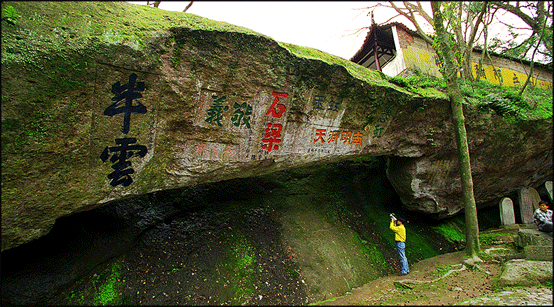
104,73,146,134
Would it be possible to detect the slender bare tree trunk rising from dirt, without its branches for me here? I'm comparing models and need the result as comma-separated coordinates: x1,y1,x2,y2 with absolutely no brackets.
431,1,481,258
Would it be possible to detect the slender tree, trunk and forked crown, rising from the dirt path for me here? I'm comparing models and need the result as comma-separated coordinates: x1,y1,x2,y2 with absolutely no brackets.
362,1,478,260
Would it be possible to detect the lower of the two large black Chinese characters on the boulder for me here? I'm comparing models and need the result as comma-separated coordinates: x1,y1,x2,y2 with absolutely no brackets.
100,138,148,187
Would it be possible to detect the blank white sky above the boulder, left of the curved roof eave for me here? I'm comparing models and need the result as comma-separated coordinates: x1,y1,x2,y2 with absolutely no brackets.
129,1,386,59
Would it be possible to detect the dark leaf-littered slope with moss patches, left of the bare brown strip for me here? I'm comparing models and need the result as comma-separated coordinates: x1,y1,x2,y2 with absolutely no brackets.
50,209,306,305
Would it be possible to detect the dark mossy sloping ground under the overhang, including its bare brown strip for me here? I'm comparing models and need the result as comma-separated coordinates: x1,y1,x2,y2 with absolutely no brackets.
46,162,466,305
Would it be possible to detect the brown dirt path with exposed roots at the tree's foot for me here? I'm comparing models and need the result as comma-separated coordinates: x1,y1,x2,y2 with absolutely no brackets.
318,251,540,306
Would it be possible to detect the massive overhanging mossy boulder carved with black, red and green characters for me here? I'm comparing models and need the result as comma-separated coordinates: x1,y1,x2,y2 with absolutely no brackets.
2,1,552,250
